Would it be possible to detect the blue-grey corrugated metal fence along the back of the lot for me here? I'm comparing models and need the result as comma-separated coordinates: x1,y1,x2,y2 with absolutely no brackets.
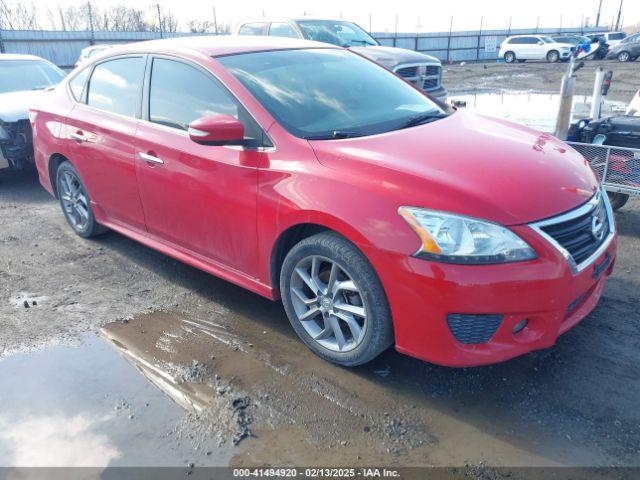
0,28,602,67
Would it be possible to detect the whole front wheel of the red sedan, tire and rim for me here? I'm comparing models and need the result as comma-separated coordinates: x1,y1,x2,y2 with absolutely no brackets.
280,232,393,367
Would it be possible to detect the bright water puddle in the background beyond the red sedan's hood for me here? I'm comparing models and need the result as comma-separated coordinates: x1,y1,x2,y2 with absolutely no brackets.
450,92,626,133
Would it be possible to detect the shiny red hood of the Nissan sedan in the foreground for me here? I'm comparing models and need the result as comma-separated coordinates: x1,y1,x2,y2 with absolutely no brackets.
310,111,598,225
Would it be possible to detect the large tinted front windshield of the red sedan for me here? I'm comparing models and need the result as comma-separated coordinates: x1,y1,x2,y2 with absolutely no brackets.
218,49,444,140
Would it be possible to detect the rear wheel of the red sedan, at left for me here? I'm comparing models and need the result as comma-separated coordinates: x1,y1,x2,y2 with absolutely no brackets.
56,162,107,238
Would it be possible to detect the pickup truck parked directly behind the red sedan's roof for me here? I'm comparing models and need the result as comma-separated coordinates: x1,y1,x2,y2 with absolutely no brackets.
235,17,447,102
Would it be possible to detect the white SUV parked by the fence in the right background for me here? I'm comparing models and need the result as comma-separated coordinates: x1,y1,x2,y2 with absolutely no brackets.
499,35,575,63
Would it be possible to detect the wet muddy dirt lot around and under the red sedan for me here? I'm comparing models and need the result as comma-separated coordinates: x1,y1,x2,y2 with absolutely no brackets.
0,64,640,470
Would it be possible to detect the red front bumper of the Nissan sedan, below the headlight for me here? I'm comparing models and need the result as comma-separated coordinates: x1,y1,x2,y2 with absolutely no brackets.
374,215,617,367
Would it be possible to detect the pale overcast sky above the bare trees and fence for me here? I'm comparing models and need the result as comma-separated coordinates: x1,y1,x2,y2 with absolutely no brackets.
77,0,640,32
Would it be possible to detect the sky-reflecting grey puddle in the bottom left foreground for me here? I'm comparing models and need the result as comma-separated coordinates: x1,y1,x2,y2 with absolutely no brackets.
0,335,232,467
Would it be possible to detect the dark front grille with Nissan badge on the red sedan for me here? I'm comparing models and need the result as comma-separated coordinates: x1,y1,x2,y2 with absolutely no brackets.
540,193,611,265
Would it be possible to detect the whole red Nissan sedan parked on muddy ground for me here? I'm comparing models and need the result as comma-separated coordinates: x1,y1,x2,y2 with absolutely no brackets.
32,36,617,366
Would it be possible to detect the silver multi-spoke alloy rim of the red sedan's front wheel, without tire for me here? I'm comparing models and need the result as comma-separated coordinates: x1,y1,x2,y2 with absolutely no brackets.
289,255,368,352
